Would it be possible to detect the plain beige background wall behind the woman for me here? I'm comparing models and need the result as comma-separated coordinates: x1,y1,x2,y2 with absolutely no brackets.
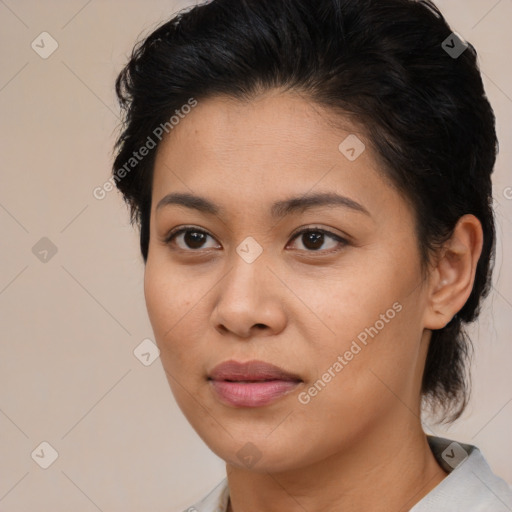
0,0,512,512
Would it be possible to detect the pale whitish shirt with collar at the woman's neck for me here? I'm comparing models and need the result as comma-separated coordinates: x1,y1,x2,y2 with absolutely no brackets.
183,436,512,512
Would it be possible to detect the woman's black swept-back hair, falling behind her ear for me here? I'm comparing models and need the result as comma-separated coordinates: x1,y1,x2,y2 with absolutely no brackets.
113,0,498,422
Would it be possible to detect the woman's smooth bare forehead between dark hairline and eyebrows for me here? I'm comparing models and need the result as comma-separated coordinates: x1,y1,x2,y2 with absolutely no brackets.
153,92,408,222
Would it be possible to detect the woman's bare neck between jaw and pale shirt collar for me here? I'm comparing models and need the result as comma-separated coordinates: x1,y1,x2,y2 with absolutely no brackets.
226,420,447,512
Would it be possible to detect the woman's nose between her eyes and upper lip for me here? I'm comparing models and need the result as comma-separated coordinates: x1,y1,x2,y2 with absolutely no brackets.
211,255,286,339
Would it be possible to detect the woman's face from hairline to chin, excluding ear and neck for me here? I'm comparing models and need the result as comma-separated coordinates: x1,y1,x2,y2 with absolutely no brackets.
145,93,428,471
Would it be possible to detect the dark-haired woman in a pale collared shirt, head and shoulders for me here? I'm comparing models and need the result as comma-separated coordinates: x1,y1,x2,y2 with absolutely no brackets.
113,0,512,512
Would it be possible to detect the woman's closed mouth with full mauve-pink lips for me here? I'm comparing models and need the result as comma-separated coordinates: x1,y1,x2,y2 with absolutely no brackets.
208,361,303,407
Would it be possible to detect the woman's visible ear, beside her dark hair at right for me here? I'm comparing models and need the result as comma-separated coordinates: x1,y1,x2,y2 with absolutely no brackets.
424,214,483,330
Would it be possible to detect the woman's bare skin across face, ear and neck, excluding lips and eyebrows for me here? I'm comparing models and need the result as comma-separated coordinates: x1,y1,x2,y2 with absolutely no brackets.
144,91,482,512
